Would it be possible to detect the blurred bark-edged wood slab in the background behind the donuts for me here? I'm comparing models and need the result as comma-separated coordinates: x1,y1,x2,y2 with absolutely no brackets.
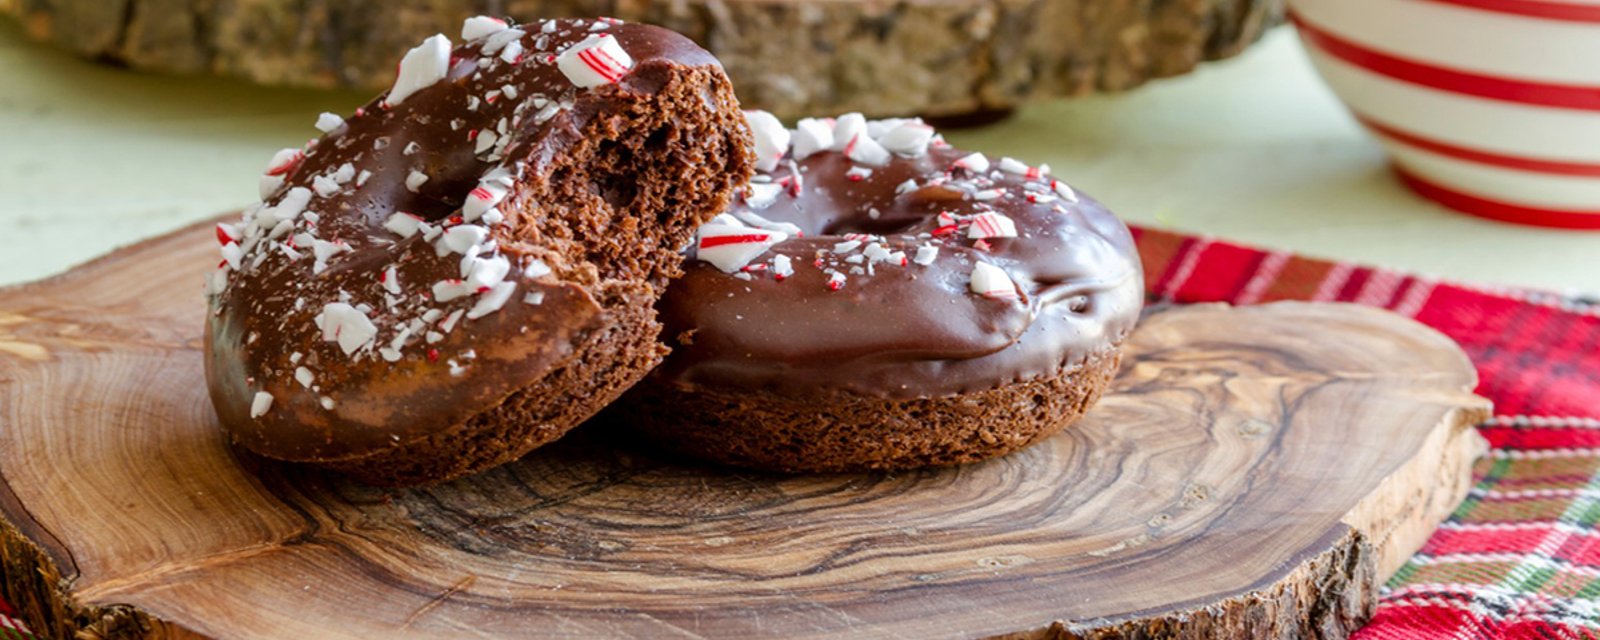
0,0,1282,117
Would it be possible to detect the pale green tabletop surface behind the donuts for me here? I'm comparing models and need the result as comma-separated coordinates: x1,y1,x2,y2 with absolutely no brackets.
0,19,1600,294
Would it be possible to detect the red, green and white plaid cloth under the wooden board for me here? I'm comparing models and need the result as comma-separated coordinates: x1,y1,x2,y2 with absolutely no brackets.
0,229,1600,640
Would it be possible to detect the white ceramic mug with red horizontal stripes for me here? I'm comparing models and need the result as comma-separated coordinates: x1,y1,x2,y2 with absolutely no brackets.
1290,0,1600,229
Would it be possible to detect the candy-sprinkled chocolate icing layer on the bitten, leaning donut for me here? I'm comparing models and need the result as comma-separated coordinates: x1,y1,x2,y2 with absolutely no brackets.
206,19,720,461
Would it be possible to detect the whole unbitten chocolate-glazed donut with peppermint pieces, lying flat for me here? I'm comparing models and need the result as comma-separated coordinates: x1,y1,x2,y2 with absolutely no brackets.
618,114,1142,472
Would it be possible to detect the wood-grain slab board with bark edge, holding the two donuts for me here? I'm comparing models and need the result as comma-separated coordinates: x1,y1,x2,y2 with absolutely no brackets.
0,217,1488,638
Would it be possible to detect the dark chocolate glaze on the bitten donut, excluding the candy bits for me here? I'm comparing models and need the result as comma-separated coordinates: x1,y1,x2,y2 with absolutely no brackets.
206,21,720,461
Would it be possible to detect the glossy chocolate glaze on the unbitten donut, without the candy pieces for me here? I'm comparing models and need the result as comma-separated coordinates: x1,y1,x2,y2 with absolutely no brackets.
653,144,1142,398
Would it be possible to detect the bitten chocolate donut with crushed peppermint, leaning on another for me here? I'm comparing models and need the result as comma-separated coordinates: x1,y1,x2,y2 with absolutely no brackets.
206,18,752,485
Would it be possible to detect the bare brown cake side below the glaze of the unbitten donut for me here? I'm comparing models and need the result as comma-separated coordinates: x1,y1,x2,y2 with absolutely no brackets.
603,349,1122,474
